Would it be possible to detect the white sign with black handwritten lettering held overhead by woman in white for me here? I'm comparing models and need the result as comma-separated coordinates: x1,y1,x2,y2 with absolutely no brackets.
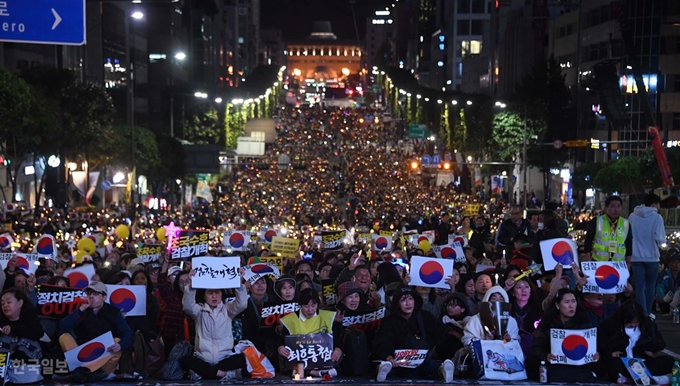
191,257,241,289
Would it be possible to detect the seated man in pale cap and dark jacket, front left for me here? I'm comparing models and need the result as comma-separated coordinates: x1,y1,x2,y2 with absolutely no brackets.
59,281,133,380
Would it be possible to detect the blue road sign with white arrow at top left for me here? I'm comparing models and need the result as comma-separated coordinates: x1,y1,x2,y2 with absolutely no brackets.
0,0,85,45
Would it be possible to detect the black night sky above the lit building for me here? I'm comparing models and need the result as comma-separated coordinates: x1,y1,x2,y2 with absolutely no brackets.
260,0,391,41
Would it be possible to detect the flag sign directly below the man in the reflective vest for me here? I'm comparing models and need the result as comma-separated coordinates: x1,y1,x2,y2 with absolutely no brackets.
581,261,630,294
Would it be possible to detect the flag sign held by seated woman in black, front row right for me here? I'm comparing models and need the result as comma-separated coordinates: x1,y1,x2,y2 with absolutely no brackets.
550,328,597,366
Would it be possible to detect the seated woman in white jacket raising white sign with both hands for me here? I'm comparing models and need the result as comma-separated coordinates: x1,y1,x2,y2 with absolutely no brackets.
180,270,248,381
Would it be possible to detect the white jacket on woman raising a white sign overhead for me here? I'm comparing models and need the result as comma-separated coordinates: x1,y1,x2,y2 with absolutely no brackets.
182,285,248,365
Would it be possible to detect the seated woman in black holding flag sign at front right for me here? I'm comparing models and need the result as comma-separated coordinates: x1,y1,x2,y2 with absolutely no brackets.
525,288,600,383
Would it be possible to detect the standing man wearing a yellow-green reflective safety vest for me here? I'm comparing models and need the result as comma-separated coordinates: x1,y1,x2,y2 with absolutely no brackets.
584,196,633,262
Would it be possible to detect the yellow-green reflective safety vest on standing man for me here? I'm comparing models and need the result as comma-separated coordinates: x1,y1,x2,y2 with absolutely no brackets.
593,215,630,261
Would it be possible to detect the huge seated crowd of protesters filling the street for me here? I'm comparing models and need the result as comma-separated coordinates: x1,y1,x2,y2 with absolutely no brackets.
0,107,680,384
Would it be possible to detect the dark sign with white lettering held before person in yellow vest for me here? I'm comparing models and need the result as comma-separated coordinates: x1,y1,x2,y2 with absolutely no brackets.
284,333,333,370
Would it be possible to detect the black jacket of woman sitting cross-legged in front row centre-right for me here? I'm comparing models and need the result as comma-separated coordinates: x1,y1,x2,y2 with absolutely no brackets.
373,310,444,360
